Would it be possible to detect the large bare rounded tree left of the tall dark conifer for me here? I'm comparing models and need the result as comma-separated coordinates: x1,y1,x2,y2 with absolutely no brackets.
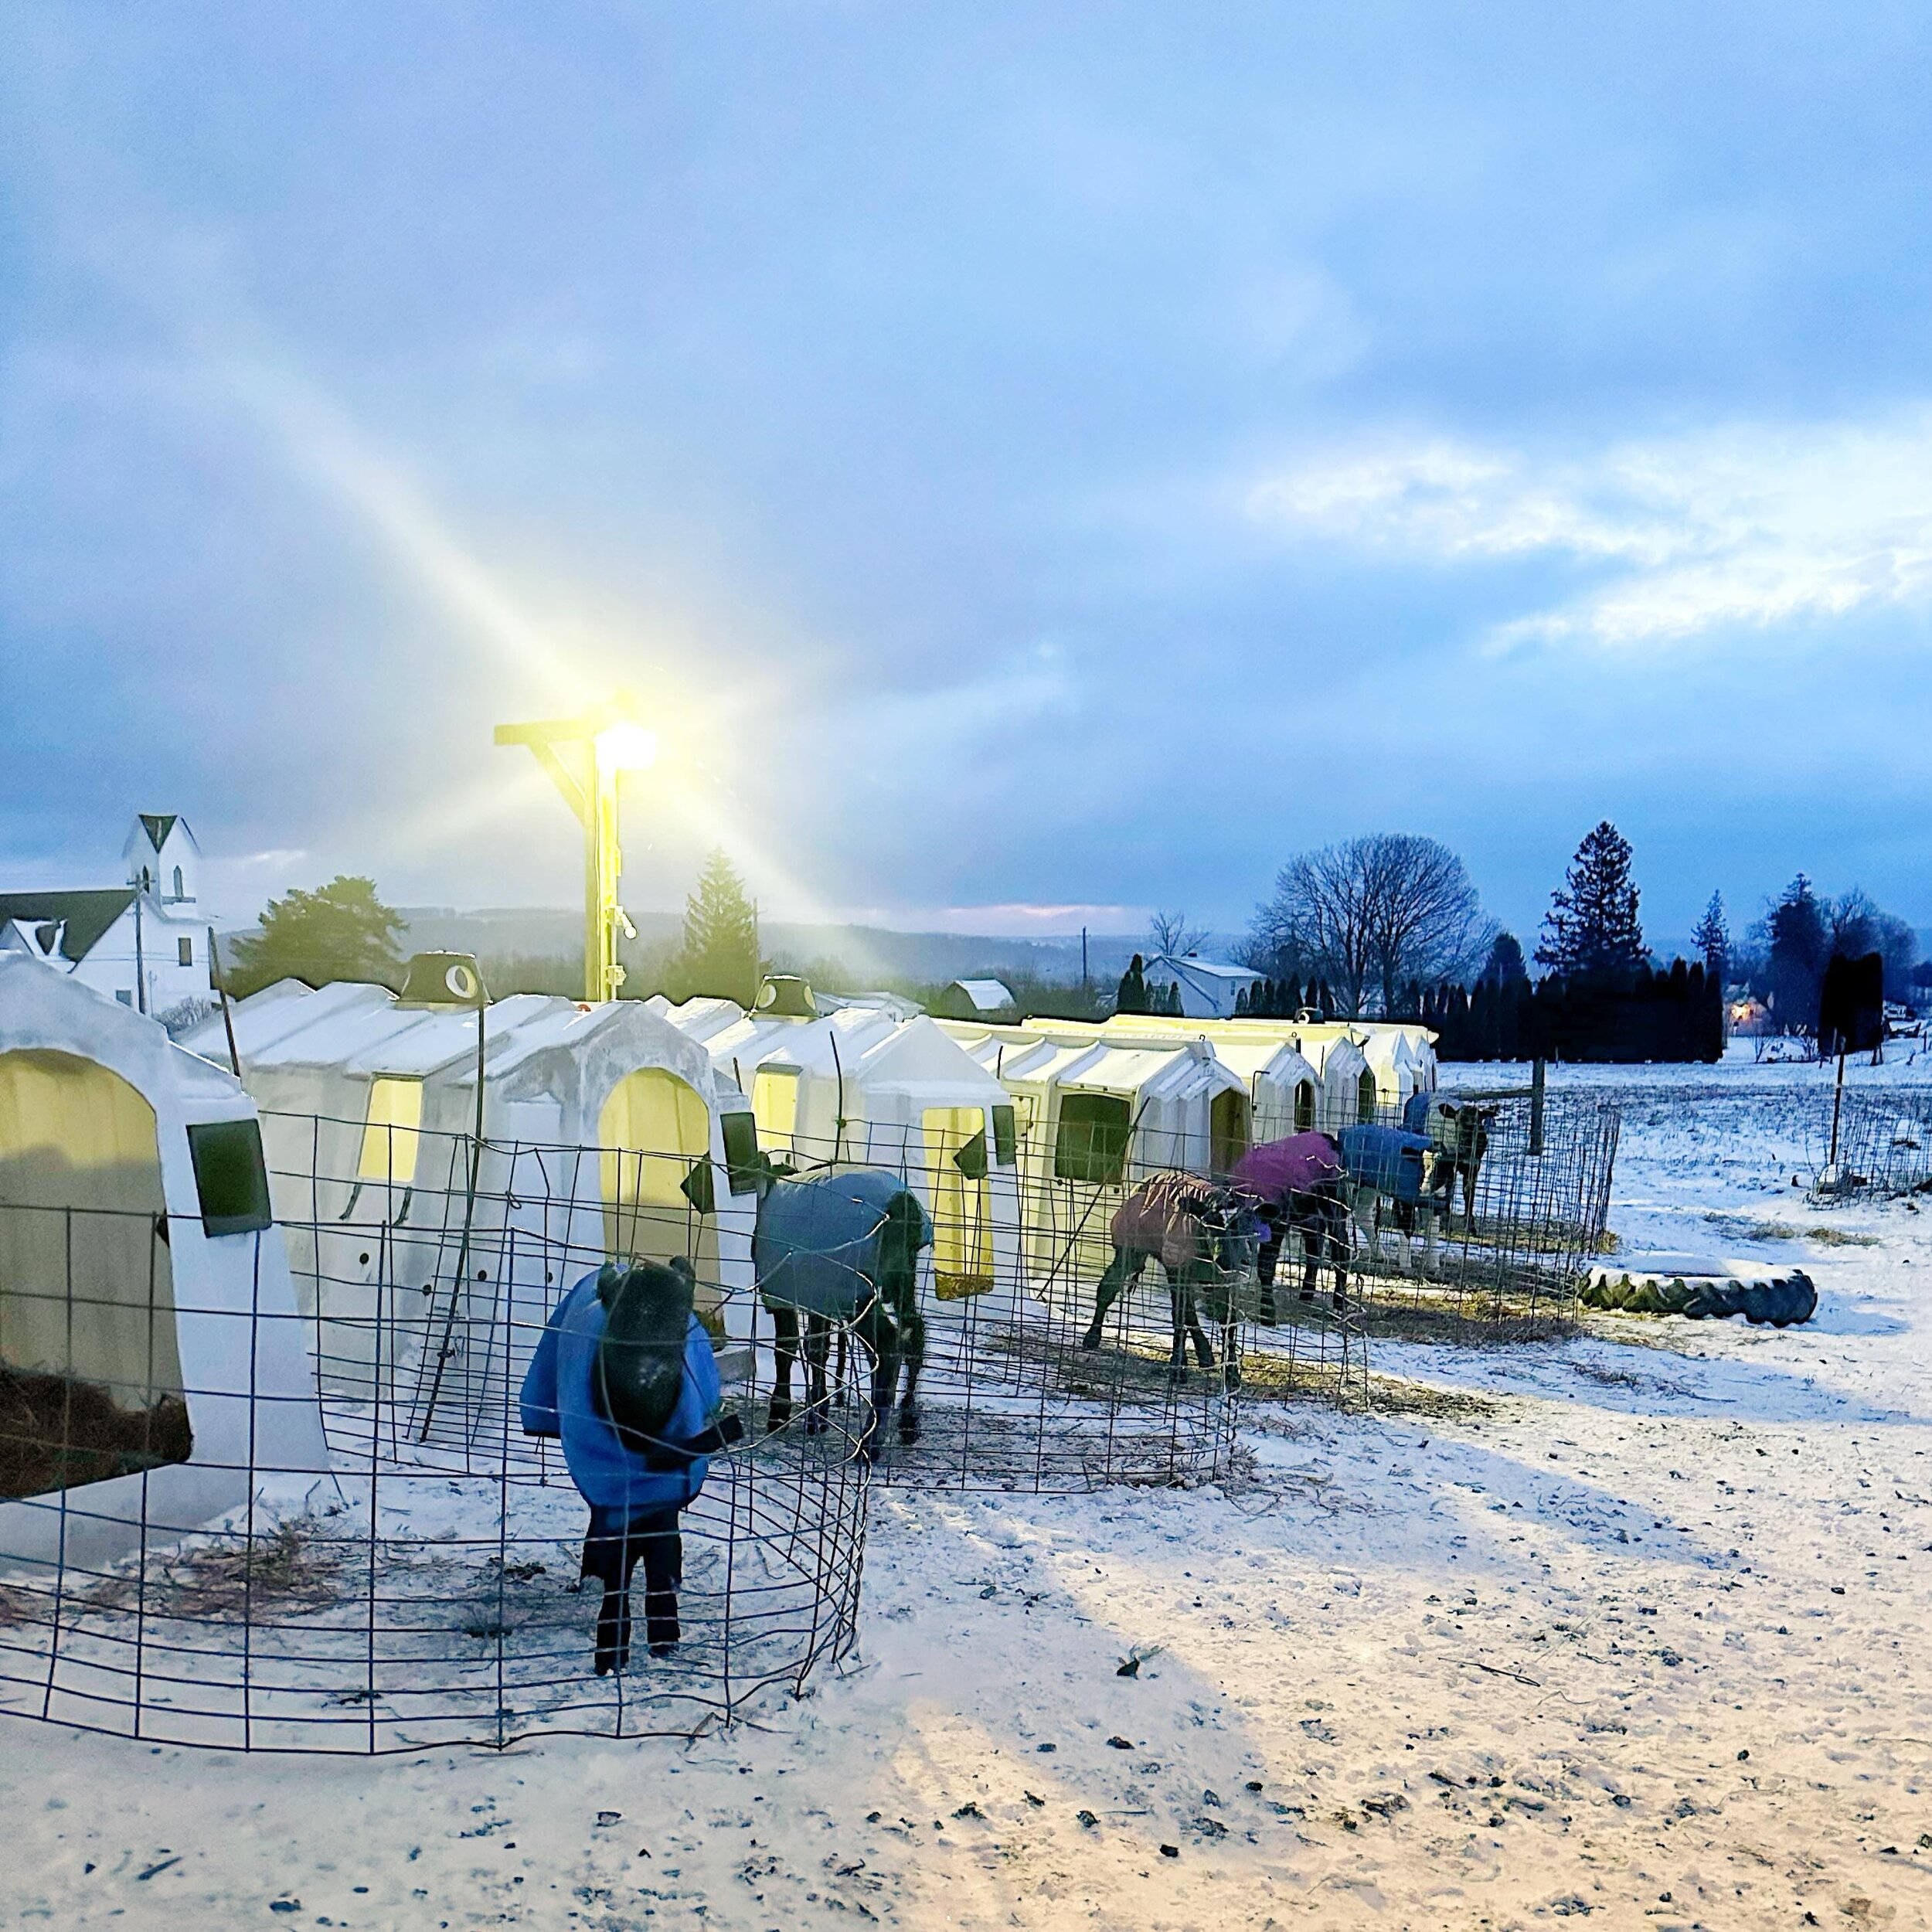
1250,833,1494,1016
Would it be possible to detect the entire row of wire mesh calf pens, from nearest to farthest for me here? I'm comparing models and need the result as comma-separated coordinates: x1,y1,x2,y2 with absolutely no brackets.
0,1097,1617,1753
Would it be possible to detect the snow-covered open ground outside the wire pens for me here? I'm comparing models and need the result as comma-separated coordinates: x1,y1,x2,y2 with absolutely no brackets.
0,1051,1932,1932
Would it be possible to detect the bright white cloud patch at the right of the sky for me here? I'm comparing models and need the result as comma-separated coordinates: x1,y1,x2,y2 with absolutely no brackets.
1248,408,1932,648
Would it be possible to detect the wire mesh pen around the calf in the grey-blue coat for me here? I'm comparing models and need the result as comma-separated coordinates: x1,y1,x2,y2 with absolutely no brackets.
263,1113,1239,1492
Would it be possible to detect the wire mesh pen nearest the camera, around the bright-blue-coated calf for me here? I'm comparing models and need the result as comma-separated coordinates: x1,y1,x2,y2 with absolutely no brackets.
0,1182,868,1753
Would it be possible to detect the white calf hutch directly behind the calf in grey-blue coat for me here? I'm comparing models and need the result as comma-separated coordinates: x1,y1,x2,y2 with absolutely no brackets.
651,999,1020,1301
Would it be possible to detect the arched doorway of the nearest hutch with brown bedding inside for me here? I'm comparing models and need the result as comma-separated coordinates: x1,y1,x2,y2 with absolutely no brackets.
0,1051,193,1499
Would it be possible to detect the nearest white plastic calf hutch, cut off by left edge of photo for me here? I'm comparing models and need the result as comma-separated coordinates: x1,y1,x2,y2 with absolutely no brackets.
0,957,328,1584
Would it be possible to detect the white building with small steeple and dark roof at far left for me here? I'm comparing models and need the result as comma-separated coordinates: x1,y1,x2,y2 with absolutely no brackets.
0,811,215,1022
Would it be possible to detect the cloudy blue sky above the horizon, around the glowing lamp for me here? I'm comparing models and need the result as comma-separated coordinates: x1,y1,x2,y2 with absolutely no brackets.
0,0,1932,937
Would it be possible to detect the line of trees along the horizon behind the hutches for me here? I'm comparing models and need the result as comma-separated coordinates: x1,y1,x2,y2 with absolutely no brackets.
226,819,1932,1059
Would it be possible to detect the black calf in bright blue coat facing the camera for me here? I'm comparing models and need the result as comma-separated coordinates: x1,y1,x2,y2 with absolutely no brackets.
522,1258,744,1677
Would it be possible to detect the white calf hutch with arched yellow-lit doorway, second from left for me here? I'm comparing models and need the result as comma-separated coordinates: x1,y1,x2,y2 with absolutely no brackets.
193,985,756,1432
